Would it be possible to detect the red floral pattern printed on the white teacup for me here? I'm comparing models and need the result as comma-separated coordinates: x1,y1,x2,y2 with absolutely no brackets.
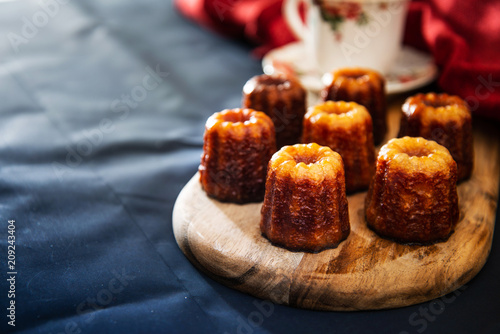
313,0,376,41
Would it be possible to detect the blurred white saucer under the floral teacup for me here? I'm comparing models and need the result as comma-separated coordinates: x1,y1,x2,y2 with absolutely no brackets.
262,42,437,94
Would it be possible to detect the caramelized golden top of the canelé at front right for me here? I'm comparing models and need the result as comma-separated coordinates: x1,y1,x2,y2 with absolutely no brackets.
377,137,457,176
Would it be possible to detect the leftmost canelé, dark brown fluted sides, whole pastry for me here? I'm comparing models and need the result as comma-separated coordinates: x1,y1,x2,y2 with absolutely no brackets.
199,109,276,203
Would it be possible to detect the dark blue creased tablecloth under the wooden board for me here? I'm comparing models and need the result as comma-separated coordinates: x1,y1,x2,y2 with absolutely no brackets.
0,0,500,333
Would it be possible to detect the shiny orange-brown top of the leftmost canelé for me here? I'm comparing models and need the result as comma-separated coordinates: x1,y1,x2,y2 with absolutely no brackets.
205,108,274,138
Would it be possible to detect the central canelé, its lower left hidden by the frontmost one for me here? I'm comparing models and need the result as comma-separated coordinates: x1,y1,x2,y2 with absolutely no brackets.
302,101,375,193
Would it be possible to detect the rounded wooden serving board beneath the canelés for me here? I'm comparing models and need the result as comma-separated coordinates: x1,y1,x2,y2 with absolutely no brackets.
173,99,500,311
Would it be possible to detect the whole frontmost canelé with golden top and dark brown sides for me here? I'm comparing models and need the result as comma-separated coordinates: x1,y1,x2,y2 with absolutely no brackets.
260,143,350,252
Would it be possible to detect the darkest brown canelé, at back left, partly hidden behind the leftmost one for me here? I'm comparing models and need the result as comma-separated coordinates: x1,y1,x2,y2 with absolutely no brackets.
243,74,306,149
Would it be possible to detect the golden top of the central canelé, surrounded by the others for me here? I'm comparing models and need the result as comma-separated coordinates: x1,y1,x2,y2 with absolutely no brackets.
305,101,371,128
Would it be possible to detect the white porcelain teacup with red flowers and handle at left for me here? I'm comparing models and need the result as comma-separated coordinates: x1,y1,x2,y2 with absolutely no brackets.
283,0,408,73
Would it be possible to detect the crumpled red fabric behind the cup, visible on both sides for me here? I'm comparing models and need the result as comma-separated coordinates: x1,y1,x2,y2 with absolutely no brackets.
176,0,500,120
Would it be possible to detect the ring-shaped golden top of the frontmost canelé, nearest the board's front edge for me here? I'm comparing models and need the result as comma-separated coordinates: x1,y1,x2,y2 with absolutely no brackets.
269,143,344,183
